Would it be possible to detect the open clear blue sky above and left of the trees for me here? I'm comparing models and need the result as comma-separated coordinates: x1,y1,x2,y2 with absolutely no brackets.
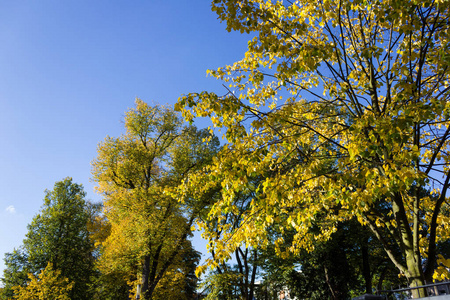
0,0,248,276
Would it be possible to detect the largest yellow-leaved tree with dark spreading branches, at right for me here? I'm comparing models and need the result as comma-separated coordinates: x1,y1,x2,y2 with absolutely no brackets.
177,0,450,296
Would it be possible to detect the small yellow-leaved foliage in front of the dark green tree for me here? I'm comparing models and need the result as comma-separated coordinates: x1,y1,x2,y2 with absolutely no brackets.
13,263,74,300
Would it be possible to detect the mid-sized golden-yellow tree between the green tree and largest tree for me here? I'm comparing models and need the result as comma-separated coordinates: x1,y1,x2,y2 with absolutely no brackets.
92,99,218,299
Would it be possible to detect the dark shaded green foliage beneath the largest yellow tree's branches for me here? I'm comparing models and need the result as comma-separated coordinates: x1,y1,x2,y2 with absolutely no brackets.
274,220,406,299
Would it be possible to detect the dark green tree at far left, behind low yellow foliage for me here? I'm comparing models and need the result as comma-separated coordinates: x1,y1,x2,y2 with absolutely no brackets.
3,178,94,299
